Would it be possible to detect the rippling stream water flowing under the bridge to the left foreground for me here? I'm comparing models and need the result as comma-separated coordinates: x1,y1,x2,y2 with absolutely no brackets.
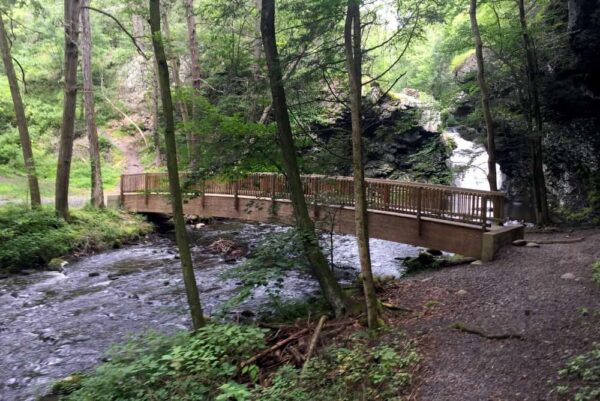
0,221,419,401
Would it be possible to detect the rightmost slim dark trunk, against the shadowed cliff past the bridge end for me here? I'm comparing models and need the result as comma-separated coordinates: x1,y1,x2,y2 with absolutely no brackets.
518,0,550,224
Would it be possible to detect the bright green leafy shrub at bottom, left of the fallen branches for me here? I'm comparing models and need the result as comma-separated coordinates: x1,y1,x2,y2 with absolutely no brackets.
65,324,265,401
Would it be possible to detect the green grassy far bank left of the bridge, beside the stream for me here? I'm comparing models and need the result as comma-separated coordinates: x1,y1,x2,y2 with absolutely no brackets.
0,205,152,272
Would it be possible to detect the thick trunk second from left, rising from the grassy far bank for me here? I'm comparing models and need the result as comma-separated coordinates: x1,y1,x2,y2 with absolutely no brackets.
55,0,80,219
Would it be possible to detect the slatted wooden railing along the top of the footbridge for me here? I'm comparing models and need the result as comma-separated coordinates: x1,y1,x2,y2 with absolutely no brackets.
121,173,504,227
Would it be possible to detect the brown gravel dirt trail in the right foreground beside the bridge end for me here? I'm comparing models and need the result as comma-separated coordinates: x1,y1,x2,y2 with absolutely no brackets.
384,230,600,401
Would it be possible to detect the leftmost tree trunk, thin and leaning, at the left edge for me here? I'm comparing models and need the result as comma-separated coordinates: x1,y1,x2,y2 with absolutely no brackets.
0,15,42,208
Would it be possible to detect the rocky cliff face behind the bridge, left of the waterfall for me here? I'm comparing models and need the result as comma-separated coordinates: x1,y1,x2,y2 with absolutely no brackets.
303,91,451,184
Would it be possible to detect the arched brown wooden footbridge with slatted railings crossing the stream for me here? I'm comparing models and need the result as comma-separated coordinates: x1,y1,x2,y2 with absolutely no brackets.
119,173,523,260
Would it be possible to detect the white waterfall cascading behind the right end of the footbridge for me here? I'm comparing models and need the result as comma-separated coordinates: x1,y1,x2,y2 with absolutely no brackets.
442,128,502,190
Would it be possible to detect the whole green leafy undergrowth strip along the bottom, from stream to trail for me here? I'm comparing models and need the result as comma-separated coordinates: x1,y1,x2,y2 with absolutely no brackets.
54,324,419,401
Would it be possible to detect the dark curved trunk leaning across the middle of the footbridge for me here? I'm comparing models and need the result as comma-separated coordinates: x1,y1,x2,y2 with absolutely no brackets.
261,0,349,316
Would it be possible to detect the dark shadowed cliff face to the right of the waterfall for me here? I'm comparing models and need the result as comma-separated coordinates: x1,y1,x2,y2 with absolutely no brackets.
446,0,600,221
